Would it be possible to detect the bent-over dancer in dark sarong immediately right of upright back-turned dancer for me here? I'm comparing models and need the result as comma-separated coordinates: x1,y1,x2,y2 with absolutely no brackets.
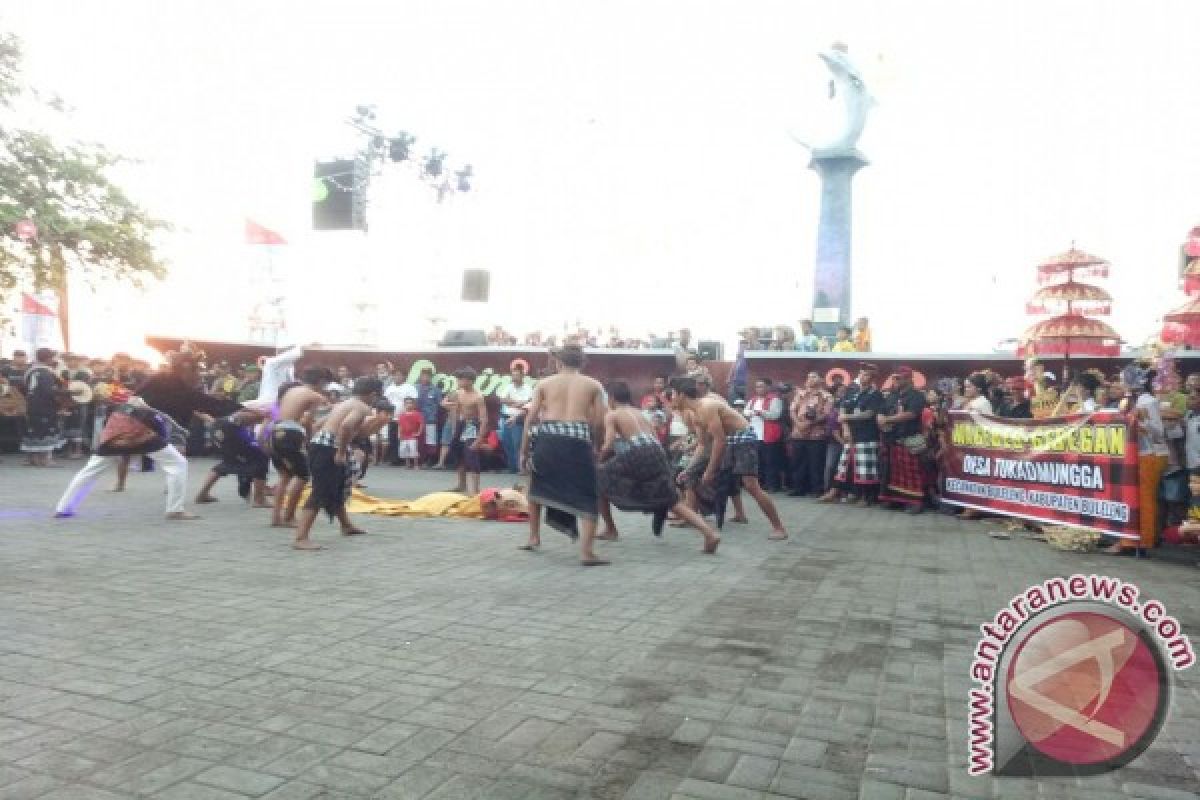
596,381,721,553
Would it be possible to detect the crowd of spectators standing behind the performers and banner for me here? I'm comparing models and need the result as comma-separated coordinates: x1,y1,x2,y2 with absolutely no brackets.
0,331,1200,556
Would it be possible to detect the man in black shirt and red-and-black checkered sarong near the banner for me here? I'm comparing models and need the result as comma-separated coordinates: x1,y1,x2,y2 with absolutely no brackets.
878,367,929,513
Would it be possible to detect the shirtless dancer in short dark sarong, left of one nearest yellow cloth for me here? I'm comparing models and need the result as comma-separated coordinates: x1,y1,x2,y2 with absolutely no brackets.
271,367,331,528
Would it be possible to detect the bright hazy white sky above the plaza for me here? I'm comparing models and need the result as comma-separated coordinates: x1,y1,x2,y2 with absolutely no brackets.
0,0,1200,353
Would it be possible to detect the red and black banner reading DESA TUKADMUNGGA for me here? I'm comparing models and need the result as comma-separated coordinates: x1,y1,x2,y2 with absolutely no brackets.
944,411,1138,539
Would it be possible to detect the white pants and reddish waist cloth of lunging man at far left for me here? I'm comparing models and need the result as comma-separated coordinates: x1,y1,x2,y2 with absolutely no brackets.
54,397,199,519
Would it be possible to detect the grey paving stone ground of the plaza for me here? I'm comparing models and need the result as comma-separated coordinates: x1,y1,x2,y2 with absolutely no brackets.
0,456,1200,800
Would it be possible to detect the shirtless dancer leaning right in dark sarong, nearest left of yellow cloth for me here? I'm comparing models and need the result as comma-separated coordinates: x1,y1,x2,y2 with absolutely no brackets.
292,378,383,551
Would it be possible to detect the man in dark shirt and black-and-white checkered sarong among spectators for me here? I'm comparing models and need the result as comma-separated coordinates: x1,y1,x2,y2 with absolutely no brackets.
820,363,883,505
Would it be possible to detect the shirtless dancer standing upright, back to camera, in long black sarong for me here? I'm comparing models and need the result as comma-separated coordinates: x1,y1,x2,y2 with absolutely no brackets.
521,345,608,566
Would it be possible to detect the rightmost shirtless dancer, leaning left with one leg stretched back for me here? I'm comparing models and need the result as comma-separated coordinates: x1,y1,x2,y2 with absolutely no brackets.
672,378,787,541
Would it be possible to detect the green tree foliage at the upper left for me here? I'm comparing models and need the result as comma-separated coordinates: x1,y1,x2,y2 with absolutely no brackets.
0,34,167,293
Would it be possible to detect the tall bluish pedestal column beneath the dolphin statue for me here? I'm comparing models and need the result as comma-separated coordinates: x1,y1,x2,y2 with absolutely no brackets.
809,149,870,339
